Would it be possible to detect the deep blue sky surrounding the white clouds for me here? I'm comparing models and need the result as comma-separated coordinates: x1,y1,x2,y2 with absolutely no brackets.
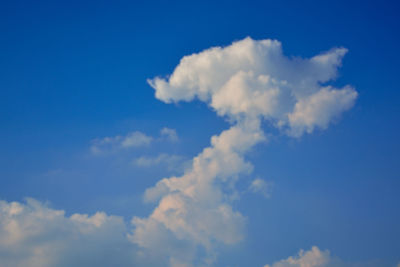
0,1,400,266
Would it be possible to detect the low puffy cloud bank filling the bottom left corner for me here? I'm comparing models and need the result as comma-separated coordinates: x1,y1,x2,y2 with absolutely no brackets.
0,199,135,267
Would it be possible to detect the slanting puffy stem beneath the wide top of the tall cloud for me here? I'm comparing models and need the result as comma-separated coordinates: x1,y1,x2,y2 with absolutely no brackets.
132,122,264,261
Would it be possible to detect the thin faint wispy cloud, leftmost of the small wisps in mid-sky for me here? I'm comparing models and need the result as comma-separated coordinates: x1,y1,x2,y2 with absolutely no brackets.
90,131,154,154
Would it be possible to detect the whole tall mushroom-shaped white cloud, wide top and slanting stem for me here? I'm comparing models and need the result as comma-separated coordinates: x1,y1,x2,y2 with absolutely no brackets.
131,38,357,264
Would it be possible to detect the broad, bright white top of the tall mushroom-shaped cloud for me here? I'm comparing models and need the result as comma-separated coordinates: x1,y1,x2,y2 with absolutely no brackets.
149,38,357,136
